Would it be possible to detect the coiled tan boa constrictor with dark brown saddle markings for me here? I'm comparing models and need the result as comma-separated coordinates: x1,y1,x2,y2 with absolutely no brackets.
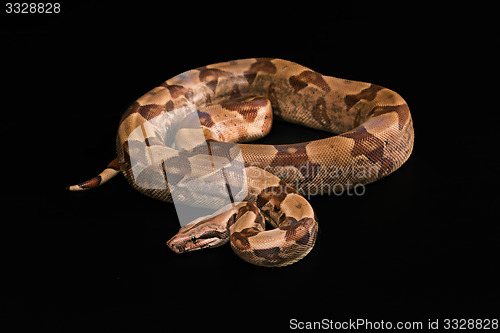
69,58,414,267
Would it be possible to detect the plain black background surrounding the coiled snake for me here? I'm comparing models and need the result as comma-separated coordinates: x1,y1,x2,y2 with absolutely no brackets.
1,1,500,332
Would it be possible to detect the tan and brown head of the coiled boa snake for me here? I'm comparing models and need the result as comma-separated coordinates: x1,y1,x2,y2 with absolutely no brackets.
167,218,229,253
